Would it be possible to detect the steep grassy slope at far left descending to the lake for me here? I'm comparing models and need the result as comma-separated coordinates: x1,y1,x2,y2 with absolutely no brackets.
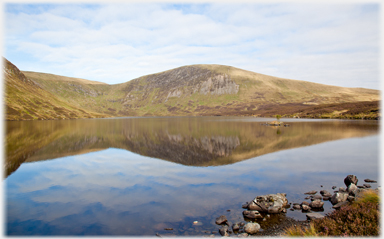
3,59,108,120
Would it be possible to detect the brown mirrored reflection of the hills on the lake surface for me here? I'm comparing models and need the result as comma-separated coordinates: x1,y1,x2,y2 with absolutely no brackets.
5,117,378,175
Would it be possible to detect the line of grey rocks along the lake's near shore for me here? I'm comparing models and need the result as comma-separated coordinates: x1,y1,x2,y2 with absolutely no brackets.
204,175,378,237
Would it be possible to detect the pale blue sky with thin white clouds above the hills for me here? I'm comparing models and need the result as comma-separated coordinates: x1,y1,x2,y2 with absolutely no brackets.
3,1,381,89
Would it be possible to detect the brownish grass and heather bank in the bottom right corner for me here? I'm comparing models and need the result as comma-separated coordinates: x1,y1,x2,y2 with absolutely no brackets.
286,190,380,237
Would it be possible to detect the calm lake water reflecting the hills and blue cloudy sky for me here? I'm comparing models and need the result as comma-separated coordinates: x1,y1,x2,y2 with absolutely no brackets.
4,117,380,236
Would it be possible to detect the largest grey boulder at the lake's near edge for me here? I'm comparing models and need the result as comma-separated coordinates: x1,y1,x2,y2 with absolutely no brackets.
253,193,288,213
